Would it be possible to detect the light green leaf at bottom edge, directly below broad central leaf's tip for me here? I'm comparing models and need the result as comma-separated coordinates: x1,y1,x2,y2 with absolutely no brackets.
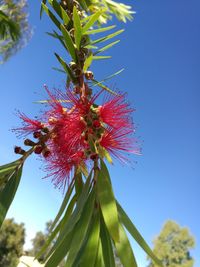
114,224,137,267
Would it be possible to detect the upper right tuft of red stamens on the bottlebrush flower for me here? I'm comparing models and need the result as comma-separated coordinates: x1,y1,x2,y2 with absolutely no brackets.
98,95,133,129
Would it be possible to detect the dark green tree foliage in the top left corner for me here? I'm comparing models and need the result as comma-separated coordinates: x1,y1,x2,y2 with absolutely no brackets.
0,0,32,63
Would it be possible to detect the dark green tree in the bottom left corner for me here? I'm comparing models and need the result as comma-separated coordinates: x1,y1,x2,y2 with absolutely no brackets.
0,219,25,267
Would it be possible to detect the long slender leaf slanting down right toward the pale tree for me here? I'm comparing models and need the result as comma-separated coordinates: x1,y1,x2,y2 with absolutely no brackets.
117,202,162,266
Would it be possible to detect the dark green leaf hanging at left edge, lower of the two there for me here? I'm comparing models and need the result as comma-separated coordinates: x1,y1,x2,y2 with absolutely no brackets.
0,165,23,227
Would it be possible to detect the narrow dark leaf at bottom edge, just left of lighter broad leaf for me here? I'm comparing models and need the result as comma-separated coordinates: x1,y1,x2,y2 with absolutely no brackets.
101,219,115,267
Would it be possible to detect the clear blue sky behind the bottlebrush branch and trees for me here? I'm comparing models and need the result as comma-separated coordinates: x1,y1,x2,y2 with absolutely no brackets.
0,0,200,267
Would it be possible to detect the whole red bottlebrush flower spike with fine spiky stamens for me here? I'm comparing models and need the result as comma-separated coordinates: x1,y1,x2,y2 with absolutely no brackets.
13,87,139,187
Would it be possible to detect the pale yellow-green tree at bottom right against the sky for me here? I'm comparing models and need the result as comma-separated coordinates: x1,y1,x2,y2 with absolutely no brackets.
148,221,195,267
